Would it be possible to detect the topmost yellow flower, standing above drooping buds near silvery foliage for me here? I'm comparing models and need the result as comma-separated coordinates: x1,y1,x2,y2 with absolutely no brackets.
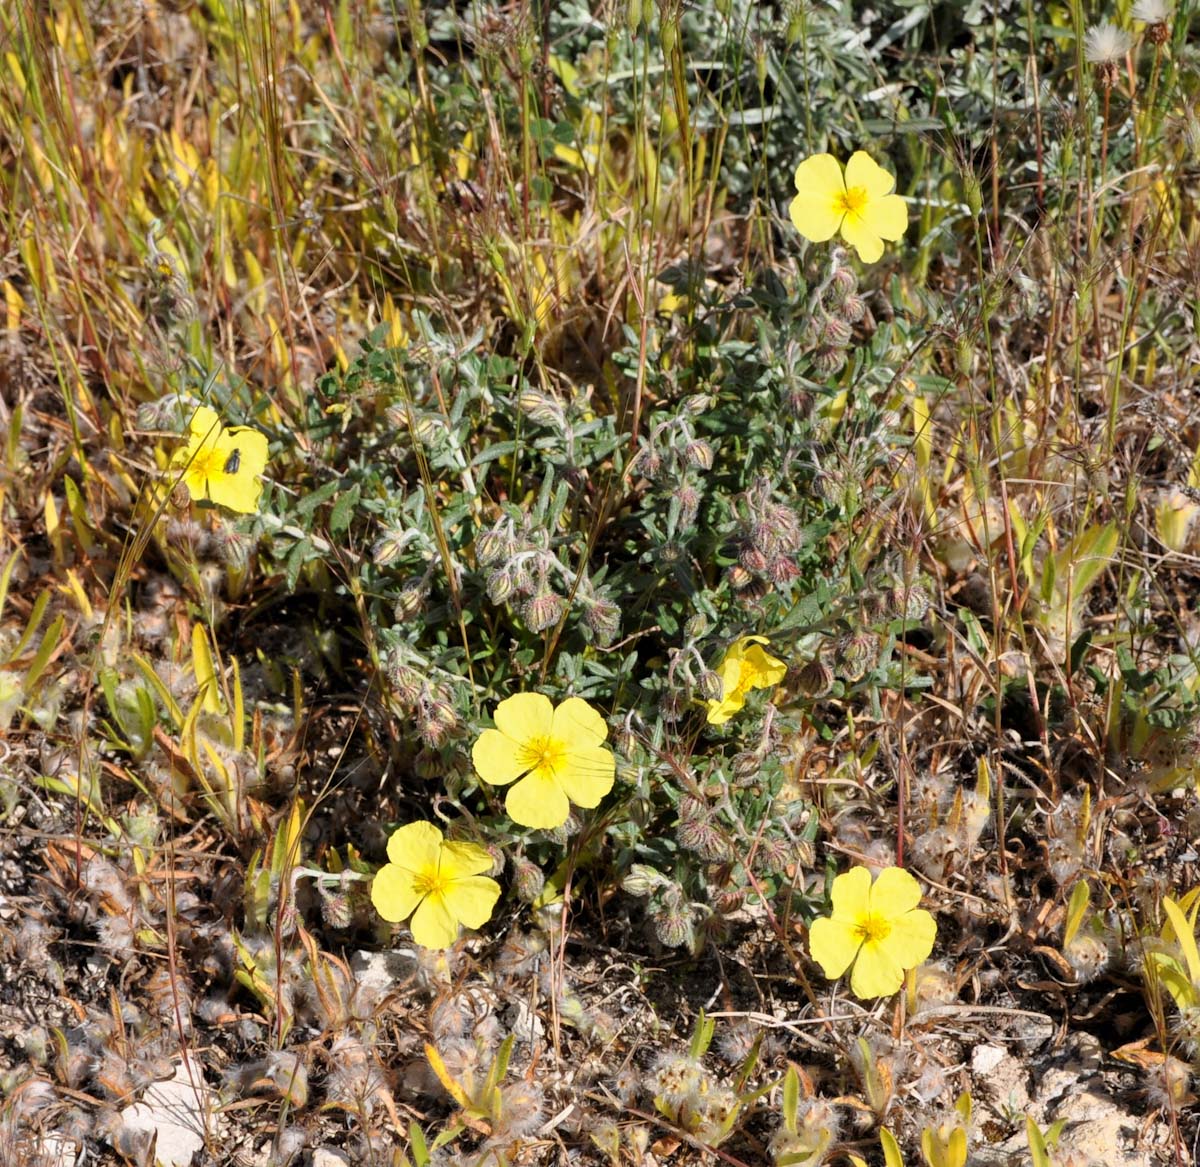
788,150,908,263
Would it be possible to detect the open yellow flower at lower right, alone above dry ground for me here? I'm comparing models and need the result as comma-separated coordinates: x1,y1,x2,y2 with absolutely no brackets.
809,867,937,998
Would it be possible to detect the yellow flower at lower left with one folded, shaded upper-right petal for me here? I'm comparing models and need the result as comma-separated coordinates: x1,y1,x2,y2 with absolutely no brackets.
371,822,500,948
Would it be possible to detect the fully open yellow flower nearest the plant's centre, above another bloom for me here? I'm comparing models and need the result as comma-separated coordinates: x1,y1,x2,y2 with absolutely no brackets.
472,693,617,831
